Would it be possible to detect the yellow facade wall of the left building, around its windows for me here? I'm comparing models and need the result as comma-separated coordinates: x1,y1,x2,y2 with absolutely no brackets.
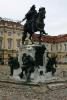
0,20,23,62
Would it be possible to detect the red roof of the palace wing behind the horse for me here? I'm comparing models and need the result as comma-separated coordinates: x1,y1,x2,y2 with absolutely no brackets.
33,34,67,43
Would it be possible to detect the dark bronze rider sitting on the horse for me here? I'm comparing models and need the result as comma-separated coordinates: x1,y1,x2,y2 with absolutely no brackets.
22,5,37,33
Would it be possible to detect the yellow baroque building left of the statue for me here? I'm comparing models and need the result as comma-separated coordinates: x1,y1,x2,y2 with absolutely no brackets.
0,18,23,62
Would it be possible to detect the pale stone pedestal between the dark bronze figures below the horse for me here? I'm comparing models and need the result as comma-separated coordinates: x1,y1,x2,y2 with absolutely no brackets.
13,44,57,83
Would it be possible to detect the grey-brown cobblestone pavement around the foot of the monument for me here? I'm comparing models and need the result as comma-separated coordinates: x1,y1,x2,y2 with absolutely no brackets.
0,66,67,100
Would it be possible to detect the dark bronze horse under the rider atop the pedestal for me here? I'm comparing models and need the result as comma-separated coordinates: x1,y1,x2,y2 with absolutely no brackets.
22,7,46,44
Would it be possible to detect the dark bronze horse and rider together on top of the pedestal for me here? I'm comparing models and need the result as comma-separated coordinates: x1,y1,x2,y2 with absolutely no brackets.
22,5,46,44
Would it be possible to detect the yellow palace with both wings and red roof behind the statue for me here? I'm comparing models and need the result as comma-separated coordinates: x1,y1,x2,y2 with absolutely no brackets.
0,18,67,65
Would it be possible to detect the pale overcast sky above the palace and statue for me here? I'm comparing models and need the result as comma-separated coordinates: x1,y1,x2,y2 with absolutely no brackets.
0,0,67,35
